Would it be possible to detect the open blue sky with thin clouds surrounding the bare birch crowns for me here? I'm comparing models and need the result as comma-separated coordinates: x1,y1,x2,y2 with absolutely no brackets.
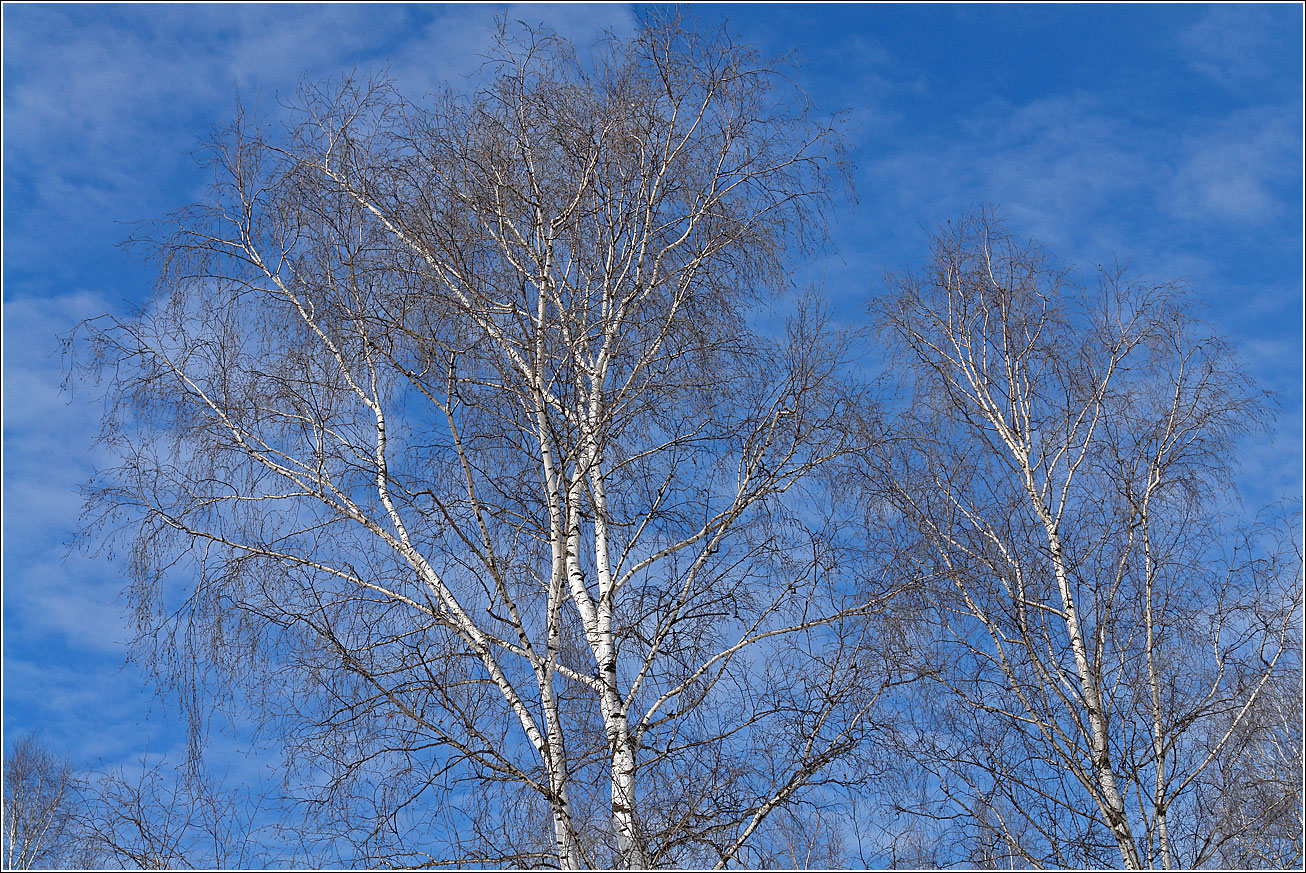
3,4,1302,836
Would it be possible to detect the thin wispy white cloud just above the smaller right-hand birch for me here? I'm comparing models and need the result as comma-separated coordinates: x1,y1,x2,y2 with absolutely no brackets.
859,74,1301,278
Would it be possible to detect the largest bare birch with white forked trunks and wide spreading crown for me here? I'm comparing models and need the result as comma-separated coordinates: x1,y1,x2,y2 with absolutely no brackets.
81,14,887,868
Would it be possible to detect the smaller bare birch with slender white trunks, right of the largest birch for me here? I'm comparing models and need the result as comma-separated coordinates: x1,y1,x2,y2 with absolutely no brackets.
875,214,1302,869
